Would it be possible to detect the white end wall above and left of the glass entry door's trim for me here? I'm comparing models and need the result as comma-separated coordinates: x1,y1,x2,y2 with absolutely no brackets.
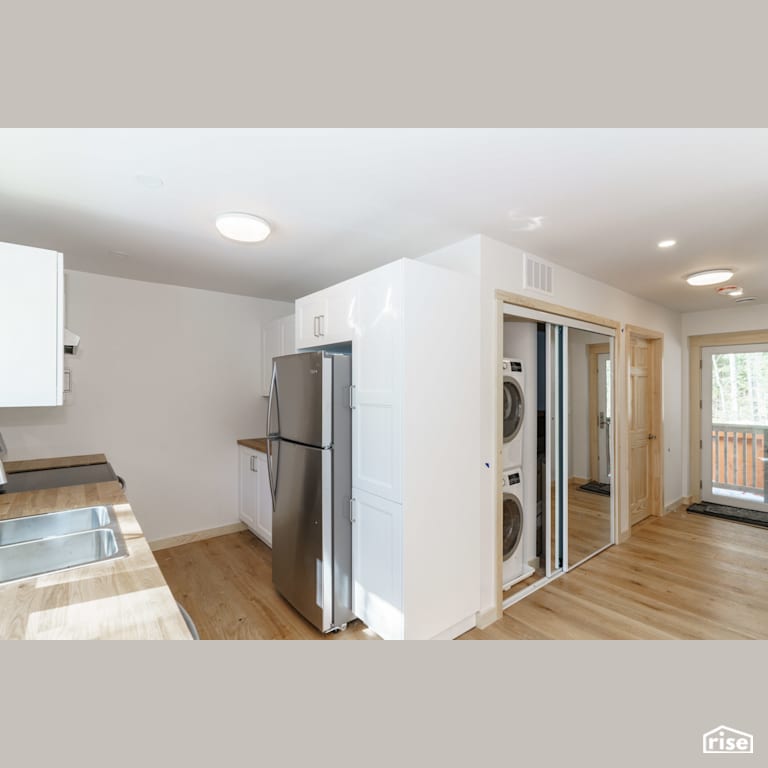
682,304,768,496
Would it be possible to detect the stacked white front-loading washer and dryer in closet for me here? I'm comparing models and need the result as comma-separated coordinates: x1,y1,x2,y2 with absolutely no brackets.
501,357,536,589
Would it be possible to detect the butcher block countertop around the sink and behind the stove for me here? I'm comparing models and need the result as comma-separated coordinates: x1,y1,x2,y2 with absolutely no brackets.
0,455,192,640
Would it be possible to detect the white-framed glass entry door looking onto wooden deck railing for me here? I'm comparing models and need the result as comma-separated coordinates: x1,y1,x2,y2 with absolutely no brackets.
701,344,768,511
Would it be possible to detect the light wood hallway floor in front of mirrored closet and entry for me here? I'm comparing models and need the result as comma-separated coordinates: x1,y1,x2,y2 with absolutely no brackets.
462,511,768,640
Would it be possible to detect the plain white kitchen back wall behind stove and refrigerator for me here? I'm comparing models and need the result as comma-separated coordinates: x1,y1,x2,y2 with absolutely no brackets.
0,271,293,541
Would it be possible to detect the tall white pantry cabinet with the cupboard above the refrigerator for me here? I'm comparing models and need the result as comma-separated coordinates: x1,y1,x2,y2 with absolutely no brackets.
296,259,482,639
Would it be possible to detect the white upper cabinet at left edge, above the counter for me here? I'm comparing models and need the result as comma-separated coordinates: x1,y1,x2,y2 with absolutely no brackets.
0,243,64,407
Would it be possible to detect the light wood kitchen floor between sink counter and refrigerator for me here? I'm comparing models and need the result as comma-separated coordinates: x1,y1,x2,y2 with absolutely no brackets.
154,531,377,640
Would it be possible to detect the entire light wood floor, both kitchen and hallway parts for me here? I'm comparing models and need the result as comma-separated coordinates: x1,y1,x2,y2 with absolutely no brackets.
155,511,768,640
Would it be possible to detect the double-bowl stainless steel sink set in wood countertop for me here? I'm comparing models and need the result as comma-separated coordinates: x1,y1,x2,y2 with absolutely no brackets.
0,507,127,583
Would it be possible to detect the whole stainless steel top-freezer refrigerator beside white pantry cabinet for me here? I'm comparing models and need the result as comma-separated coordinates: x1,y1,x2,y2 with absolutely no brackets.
267,351,355,632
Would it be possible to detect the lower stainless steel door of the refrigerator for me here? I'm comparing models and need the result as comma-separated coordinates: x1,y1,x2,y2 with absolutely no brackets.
272,440,333,632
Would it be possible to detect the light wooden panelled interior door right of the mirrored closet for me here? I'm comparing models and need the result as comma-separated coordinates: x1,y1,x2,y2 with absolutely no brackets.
629,336,653,525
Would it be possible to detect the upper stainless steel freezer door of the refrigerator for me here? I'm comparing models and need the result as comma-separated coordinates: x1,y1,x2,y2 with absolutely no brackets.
267,352,332,447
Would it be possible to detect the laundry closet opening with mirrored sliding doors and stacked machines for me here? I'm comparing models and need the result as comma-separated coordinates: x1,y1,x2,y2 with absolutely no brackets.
499,303,617,607
